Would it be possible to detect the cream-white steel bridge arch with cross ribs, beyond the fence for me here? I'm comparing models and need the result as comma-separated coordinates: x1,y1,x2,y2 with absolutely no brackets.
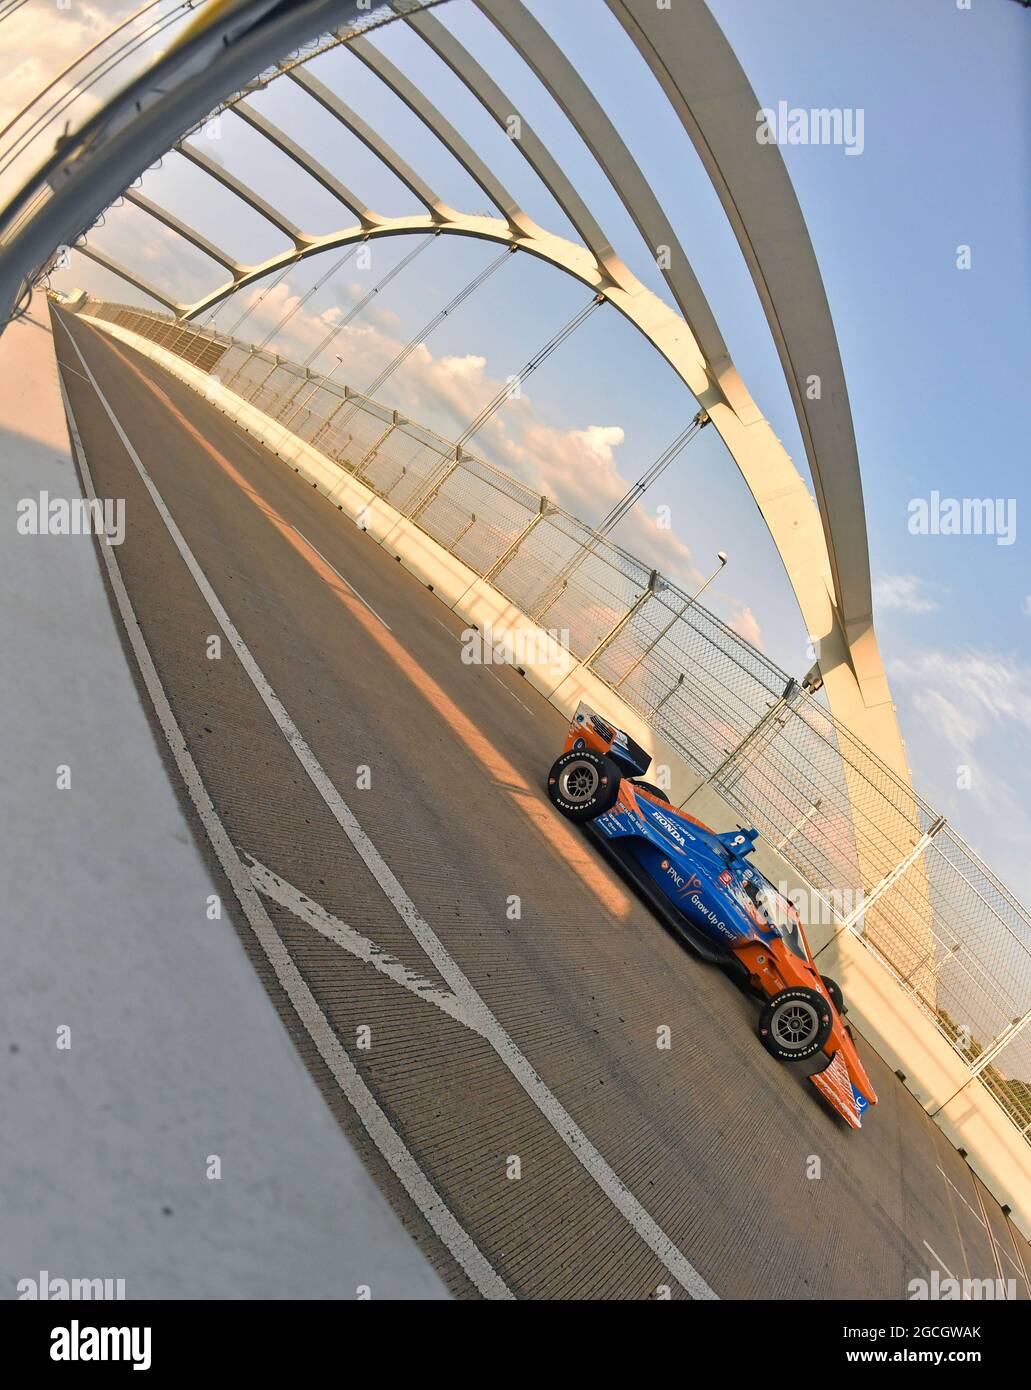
82,0,909,778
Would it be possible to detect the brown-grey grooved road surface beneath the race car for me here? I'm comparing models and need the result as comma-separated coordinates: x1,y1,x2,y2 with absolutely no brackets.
54,307,1031,1298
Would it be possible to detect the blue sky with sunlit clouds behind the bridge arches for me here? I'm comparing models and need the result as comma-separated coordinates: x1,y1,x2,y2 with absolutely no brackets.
0,0,1031,899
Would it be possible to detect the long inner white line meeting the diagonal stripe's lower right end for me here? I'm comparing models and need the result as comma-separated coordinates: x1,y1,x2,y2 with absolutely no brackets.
56,315,718,1298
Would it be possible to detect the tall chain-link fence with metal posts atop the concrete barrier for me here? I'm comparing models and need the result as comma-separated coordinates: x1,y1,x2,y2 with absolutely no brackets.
86,303,1031,1143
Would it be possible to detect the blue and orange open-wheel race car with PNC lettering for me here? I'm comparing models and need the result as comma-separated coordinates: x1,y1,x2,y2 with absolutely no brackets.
547,702,877,1129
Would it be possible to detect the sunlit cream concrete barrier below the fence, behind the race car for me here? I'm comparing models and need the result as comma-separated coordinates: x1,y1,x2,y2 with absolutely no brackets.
79,314,1031,1240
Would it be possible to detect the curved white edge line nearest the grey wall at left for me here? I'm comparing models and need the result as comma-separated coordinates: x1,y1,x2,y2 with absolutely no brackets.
60,325,514,1298
